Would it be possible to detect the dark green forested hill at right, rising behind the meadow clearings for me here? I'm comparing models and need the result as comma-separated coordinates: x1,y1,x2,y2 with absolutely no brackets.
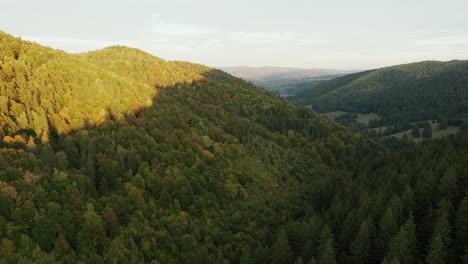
293,60,468,125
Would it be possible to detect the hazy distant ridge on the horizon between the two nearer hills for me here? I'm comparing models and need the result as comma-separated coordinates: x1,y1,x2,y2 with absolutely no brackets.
220,66,352,81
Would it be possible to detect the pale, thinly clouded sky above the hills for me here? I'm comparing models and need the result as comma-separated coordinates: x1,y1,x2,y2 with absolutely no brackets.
0,0,468,70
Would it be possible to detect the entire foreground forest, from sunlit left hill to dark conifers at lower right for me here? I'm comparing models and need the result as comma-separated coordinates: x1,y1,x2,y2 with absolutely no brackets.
0,33,468,264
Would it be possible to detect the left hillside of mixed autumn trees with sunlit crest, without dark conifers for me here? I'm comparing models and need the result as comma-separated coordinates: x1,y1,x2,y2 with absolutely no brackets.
0,33,365,263
